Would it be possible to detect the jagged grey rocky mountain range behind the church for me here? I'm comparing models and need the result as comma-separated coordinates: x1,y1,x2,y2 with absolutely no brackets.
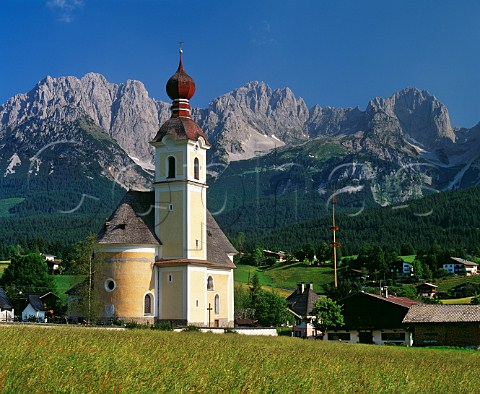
0,73,480,246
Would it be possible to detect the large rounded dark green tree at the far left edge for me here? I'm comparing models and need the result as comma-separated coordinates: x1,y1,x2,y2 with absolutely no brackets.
0,253,55,298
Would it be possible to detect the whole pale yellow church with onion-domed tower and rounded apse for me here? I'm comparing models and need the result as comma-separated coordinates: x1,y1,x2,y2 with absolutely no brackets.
93,50,237,327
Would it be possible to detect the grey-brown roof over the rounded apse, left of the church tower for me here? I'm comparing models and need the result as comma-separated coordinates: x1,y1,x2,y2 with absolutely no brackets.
98,190,161,245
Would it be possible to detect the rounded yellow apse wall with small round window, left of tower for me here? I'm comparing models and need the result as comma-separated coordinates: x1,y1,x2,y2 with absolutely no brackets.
94,249,155,322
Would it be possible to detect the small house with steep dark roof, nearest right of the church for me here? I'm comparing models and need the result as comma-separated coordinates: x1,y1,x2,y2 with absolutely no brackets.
287,283,320,338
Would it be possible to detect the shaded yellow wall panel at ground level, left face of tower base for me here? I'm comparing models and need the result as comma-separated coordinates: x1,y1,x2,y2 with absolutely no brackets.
160,270,186,320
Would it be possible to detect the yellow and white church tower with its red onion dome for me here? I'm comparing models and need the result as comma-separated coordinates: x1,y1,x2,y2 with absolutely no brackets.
151,50,210,260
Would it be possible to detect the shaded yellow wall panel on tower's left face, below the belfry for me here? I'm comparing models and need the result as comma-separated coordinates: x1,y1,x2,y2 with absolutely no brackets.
160,191,185,258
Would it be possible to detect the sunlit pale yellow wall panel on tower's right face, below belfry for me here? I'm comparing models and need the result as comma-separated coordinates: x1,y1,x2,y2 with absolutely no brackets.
188,189,207,259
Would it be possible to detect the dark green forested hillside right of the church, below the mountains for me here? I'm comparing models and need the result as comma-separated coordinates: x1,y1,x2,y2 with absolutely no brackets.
217,186,480,254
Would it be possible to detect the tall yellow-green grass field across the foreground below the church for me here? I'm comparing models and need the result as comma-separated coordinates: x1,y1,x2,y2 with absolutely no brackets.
0,326,480,393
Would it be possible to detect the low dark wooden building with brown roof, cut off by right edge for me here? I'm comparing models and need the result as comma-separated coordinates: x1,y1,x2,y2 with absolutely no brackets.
403,304,480,347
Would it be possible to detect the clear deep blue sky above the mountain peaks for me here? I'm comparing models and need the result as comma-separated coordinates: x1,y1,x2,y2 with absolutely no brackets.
0,0,480,127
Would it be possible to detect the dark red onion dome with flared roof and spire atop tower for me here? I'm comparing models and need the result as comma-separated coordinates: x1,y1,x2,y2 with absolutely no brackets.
151,49,210,145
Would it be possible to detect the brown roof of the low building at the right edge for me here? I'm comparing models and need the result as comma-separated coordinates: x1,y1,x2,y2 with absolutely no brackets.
403,304,480,323
